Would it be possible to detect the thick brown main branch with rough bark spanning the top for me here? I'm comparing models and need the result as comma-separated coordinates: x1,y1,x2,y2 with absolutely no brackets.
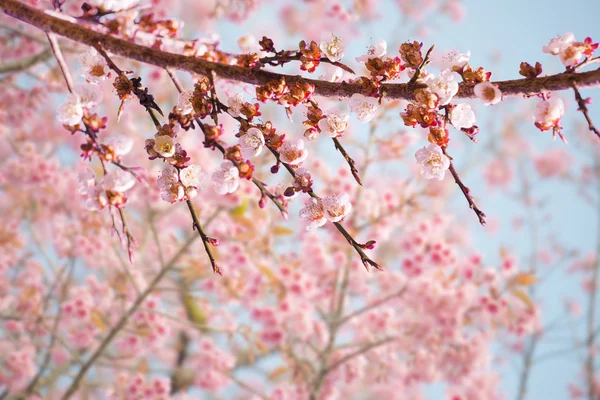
0,0,600,99
